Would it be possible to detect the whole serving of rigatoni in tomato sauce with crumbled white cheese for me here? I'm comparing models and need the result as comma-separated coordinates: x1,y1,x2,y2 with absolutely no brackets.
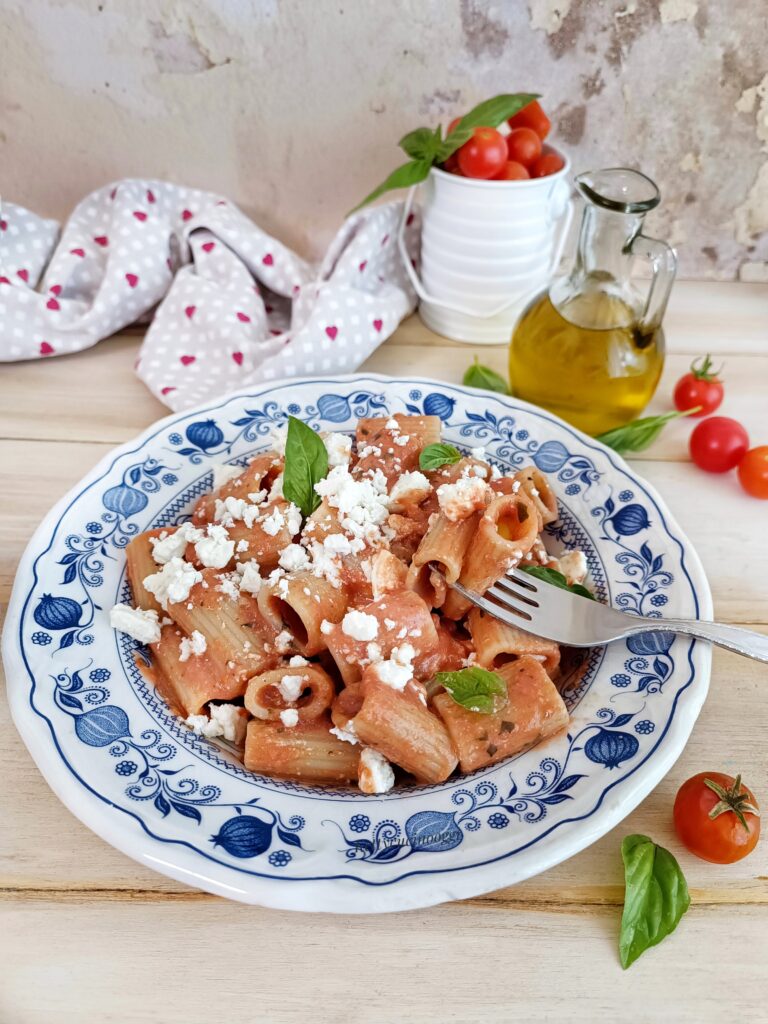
114,414,586,794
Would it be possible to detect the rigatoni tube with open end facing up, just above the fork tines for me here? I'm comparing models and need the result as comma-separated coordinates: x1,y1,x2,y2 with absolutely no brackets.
443,494,539,618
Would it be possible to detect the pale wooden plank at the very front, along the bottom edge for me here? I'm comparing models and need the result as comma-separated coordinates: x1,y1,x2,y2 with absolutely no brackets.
0,899,768,1024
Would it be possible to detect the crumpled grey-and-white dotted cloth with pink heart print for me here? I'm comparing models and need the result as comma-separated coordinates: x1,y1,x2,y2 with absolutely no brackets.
0,179,419,410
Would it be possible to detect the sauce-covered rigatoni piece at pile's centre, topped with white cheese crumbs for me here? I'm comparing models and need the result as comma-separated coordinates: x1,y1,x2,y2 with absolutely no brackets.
325,590,437,685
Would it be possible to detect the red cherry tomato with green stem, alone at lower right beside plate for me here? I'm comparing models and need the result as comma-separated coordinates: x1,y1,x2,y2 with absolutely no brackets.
673,771,760,864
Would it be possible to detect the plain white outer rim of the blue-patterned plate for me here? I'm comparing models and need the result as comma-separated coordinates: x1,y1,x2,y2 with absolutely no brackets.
2,371,713,913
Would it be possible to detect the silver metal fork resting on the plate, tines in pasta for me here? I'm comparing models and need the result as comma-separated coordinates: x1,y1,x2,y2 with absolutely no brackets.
450,569,768,663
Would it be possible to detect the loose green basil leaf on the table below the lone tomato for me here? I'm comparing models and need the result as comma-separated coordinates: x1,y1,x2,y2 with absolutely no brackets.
618,836,690,968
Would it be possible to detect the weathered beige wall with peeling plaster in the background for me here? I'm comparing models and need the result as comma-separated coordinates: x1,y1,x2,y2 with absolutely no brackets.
0,0,768,280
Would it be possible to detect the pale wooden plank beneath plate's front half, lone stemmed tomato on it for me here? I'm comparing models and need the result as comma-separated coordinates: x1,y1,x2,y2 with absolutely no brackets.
0,629,768,908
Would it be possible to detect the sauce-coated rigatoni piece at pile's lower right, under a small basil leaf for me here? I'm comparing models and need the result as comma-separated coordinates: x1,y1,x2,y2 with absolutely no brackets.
434,655,568,772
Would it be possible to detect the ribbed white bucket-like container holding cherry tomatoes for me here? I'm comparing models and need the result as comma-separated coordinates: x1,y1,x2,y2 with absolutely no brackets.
399,159,572,345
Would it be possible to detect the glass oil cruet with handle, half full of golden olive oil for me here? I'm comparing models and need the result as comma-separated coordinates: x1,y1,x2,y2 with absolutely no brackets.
509,167,677,434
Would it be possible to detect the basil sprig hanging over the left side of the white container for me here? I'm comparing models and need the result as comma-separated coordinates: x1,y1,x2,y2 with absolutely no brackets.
350,92,539,213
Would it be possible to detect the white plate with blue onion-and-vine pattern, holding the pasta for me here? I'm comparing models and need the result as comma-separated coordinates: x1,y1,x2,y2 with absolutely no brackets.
3,374,712,912
